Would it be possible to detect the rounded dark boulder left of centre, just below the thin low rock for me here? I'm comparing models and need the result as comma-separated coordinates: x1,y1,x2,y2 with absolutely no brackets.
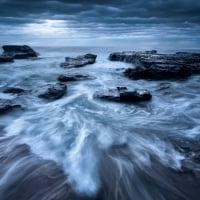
38,83,67,100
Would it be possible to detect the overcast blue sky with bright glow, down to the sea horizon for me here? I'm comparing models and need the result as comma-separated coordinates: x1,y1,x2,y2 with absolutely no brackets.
0,0,200,49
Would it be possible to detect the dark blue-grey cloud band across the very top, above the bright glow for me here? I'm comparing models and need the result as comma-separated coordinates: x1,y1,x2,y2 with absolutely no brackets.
0,0,200,24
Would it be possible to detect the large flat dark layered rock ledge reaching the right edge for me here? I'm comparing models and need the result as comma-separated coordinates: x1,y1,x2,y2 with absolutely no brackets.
109,50,200,80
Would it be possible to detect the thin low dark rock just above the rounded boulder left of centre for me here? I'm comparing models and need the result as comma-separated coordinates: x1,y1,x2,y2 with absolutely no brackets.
58,73,91,82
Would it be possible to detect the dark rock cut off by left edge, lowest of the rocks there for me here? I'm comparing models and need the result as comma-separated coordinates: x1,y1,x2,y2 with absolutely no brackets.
0,99,22,114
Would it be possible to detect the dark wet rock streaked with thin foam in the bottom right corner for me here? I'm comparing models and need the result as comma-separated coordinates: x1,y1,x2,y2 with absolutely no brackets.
99,145,200,200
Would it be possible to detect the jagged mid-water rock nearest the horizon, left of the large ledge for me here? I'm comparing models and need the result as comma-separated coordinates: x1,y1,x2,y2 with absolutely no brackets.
60,53,97,68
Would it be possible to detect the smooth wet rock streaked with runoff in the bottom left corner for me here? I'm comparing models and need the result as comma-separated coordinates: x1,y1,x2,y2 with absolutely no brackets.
0,140,101,200
